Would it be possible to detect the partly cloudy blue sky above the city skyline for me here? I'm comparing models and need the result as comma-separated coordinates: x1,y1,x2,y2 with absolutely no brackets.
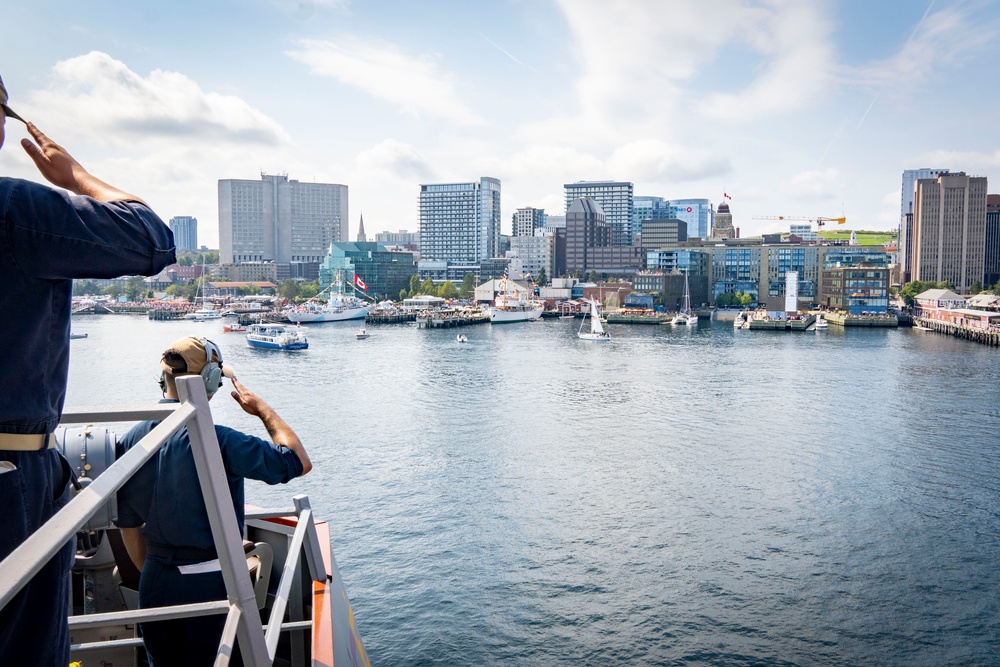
0,0,1000,247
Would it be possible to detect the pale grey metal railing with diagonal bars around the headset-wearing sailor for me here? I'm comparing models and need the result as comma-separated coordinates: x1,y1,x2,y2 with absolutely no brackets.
0,377,328,667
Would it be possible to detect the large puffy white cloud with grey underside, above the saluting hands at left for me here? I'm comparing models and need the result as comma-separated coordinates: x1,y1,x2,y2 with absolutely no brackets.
24,51,290,146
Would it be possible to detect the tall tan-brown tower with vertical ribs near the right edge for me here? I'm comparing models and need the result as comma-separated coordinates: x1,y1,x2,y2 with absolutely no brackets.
911,172,987,292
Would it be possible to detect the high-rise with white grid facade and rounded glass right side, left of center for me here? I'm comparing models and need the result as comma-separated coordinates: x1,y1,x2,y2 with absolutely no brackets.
420,176,500,265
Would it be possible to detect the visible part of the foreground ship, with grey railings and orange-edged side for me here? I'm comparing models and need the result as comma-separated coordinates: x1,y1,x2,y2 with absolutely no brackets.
0,377,370,667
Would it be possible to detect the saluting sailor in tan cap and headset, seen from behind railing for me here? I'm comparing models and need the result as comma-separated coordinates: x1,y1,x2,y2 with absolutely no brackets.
117,337,312,667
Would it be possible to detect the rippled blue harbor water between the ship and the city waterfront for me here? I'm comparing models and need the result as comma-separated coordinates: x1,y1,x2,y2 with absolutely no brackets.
67,316,1000,667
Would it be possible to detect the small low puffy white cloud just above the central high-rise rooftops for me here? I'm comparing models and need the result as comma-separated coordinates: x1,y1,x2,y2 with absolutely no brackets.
606,139,730,183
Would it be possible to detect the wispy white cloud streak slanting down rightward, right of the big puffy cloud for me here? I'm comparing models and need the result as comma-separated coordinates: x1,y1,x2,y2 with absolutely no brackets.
287,38,485,125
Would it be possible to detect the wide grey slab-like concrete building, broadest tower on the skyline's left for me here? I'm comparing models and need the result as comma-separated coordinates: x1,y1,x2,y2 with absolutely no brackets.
219,173,348,264
